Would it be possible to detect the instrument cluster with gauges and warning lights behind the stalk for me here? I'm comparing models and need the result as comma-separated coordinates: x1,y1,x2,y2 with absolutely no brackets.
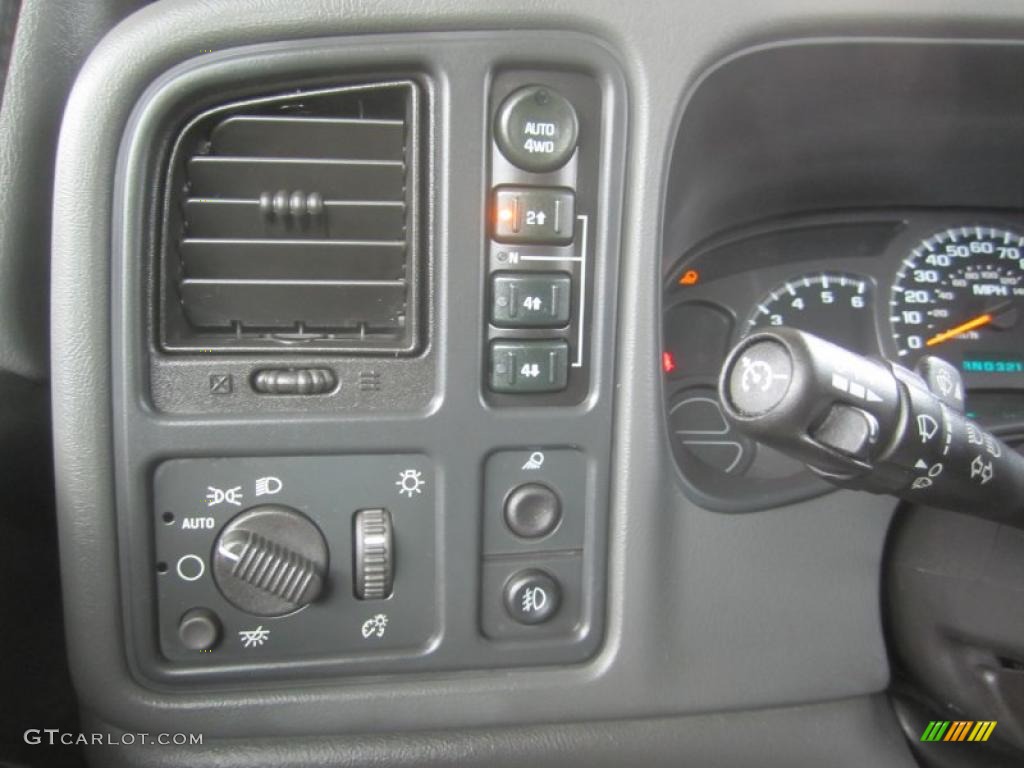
662,210,1024,507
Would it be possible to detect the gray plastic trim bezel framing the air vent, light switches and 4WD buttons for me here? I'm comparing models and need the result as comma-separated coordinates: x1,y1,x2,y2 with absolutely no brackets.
112,33,625,690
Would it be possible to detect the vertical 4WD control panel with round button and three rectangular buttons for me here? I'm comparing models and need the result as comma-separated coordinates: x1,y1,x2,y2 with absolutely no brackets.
485,71,601,406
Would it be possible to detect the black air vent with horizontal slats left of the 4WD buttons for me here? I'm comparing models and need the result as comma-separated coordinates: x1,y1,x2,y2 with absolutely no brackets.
157,78,426,356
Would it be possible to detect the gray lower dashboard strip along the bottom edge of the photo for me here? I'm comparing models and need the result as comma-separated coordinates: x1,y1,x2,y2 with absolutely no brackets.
81,696,913,768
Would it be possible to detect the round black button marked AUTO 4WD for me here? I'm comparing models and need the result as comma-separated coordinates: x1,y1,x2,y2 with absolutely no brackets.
495,85,580,173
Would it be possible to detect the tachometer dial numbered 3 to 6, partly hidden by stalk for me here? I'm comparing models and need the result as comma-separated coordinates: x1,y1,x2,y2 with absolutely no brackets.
743,272,878,353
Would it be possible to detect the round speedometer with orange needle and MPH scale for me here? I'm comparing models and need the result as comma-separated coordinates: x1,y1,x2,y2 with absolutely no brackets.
890,226,1024,373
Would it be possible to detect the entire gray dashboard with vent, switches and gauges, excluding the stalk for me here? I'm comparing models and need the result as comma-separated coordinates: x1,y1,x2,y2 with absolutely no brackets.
19,0,1024,768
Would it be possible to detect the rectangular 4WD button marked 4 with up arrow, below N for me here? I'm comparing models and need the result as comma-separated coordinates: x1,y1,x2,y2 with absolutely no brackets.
490,272,572,328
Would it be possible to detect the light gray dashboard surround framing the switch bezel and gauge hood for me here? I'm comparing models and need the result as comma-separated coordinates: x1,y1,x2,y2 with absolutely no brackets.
52,0,1021,765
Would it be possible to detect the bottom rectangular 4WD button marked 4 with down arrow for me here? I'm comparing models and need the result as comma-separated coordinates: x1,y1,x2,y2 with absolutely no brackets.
490,339,569,393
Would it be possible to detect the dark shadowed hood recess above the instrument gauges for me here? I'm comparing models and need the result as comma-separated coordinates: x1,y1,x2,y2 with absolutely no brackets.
664,41,1024,268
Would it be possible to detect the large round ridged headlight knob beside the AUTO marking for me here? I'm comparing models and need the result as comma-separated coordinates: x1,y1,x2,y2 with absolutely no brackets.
213,504,328,616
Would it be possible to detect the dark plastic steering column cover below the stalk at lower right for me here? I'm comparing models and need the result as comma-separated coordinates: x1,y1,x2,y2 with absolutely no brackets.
885,507,1024,753
